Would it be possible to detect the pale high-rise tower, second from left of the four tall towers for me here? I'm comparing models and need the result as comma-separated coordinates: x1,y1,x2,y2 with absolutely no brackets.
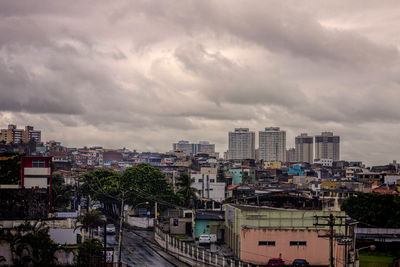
258,127,286,162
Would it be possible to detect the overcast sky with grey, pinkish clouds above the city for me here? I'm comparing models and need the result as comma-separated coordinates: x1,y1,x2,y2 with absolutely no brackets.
0,0,400,164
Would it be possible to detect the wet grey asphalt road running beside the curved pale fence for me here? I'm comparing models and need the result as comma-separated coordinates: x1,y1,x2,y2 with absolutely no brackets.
107,230,174,267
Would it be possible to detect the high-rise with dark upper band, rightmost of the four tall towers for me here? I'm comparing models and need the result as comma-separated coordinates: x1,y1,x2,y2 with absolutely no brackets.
314,132,340,161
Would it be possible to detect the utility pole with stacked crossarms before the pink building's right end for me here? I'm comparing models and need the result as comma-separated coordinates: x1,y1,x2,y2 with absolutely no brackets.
314,213,346,267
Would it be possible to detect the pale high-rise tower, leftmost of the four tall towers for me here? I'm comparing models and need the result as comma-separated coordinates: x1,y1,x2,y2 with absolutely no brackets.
228,128,256,160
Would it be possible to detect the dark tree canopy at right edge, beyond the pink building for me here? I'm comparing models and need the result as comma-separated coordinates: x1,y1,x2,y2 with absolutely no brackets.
342,193,400,228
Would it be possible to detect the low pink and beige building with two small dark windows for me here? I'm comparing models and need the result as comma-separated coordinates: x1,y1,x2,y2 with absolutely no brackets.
225,204,352,266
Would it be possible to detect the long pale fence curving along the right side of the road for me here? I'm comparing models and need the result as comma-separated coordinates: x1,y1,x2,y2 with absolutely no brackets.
154,226,253,267
